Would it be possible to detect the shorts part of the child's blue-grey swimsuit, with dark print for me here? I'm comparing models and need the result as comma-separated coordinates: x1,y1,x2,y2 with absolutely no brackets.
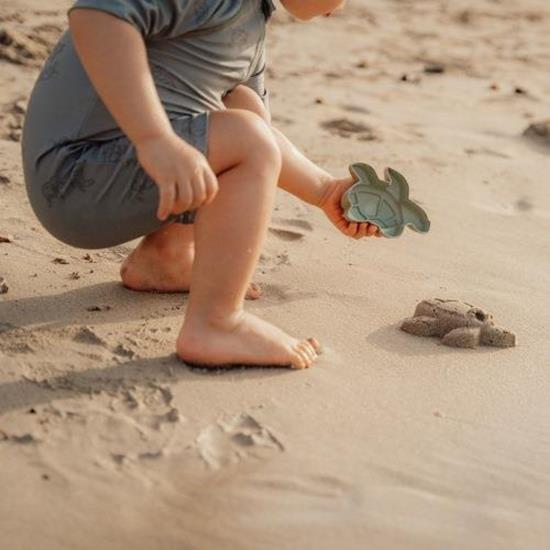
26,113,208,249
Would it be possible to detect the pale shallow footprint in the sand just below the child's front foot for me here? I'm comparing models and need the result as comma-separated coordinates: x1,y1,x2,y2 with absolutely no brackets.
196,413,285,470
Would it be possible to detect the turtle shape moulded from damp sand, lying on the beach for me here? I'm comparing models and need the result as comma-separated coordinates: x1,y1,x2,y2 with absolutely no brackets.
401,298,516,348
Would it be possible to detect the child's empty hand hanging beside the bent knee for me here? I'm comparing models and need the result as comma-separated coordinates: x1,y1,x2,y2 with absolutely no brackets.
136,133,218,221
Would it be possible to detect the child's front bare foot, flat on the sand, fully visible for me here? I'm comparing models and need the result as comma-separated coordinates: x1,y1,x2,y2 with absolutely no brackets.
176,312,321,369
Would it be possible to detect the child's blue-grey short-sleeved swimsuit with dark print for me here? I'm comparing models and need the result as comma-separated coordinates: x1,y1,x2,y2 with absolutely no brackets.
23,0,272,248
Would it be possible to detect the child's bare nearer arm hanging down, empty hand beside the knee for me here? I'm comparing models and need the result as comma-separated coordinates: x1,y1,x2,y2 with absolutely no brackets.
69,9,218,220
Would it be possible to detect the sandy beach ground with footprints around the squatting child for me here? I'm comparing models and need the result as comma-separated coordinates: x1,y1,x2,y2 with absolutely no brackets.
0,0,550,550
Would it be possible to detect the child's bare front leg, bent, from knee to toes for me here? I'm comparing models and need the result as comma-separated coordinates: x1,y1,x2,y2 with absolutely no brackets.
177,110,317,368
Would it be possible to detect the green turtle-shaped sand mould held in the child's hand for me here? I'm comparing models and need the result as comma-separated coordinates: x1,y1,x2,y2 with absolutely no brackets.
342,163,430,238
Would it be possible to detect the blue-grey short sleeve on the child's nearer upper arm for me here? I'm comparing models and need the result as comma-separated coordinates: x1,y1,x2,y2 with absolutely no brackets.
69,0,184,38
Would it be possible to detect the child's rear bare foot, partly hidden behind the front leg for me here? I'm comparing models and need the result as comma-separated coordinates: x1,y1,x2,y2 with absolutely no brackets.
120,224,262,300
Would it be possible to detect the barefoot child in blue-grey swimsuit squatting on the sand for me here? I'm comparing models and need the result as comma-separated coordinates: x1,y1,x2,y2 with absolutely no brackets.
23,0,378,368
